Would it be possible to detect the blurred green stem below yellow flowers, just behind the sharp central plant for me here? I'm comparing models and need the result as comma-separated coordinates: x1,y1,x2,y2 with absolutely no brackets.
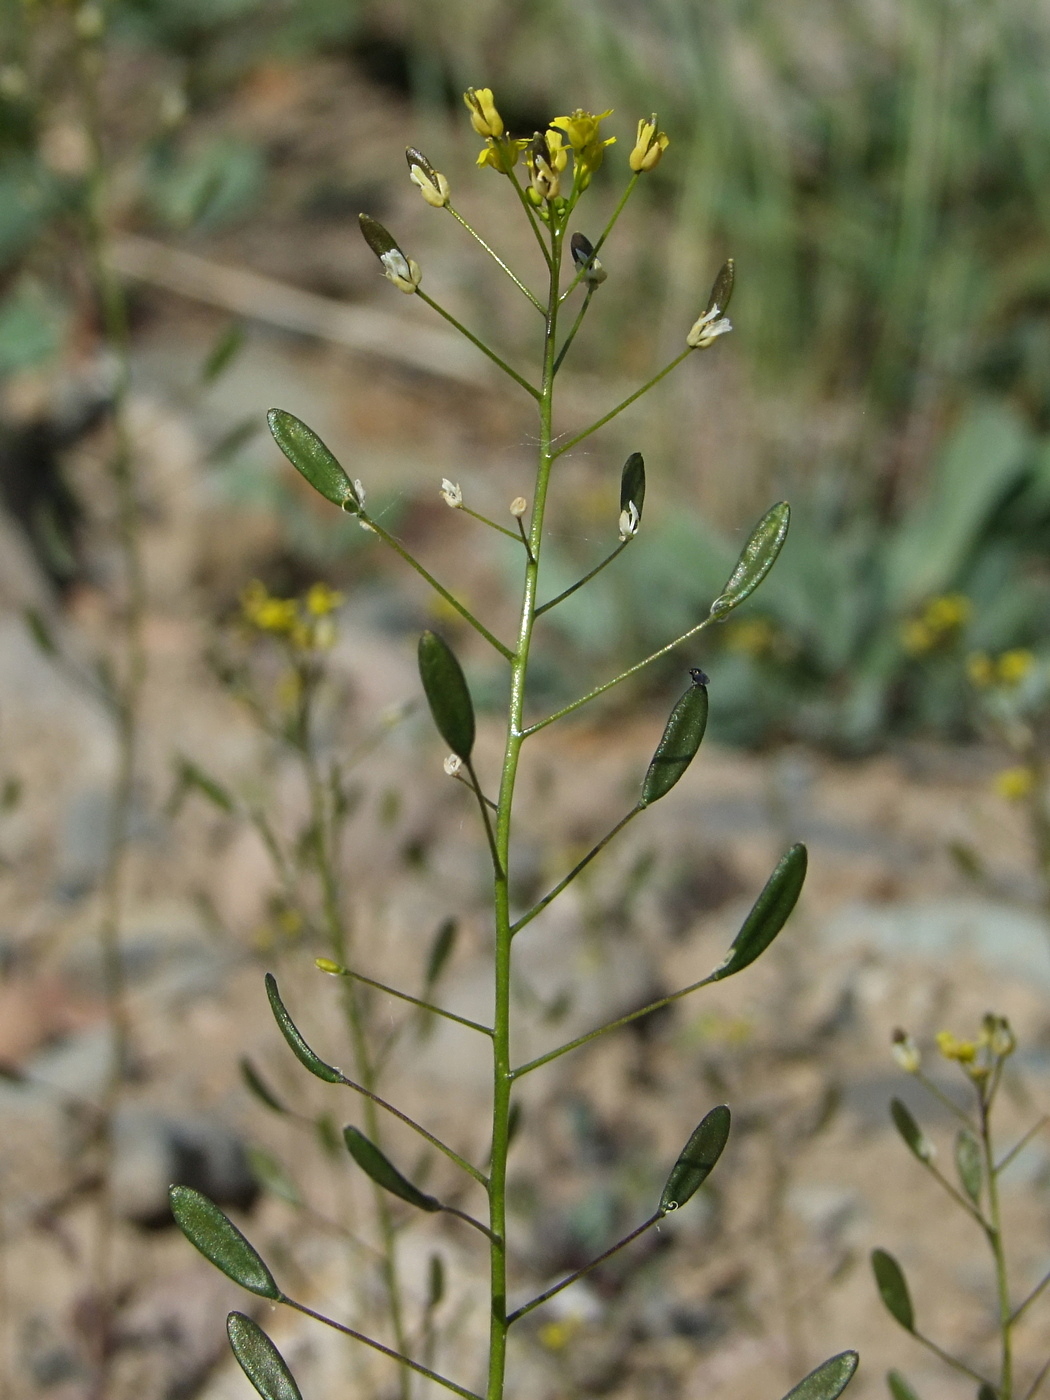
301,739,412,1400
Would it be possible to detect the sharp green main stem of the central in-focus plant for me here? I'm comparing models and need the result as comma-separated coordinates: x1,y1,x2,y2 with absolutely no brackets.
487,212,564,1400
